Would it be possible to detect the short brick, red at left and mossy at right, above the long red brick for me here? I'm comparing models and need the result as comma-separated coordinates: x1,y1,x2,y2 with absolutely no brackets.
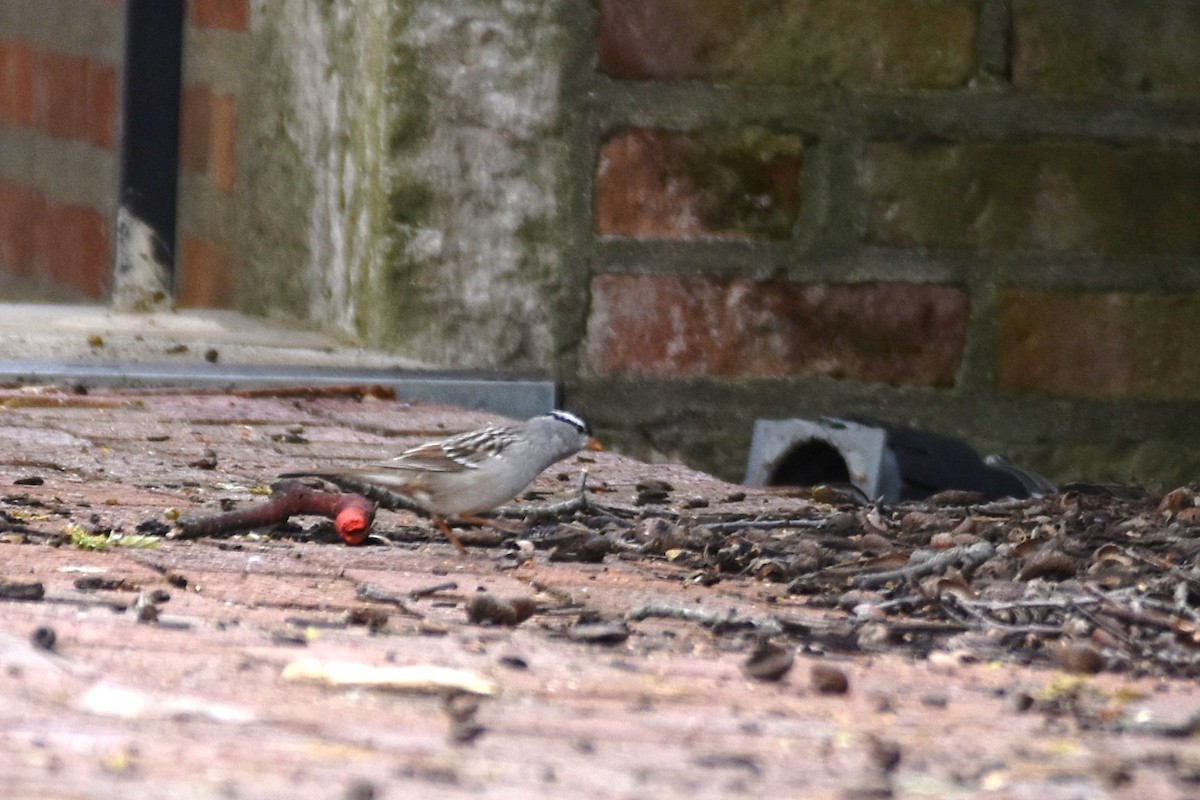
595,128,803,239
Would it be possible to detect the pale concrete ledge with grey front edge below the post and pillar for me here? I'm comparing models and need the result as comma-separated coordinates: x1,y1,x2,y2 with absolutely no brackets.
0,305,557,419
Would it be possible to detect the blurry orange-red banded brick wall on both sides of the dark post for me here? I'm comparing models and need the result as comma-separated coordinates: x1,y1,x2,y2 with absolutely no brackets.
0,0,250,307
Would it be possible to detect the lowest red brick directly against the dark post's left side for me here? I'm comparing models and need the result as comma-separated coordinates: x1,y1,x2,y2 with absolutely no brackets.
35,204,113,300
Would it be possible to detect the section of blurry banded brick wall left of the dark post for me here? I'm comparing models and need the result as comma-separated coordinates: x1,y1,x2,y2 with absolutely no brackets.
0,0,120,300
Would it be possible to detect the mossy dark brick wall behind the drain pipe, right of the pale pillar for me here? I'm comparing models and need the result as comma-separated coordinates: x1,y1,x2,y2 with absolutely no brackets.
568,0,1200,480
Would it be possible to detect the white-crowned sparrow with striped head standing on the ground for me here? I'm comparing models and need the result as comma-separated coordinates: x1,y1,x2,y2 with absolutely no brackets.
281,410,601,543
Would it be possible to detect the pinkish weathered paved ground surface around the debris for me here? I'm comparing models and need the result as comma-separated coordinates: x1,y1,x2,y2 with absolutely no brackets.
0,389,1200,799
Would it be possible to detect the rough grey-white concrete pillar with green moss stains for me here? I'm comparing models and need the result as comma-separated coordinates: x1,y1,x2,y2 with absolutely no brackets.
177,0,565,368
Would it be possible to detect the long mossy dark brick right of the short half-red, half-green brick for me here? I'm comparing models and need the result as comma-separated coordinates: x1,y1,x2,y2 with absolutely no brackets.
865,142,1200,255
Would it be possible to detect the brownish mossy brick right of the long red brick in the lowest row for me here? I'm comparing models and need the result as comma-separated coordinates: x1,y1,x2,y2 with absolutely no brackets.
996,289,1200,399
